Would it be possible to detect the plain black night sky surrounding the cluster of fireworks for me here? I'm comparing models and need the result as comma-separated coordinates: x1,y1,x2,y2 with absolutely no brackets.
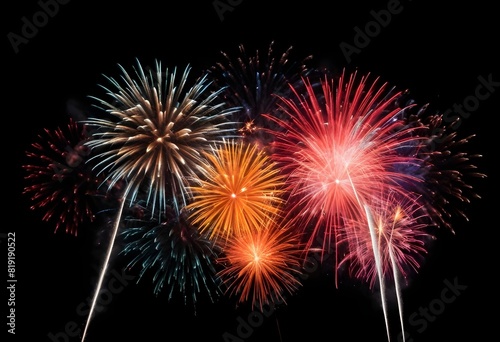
0,0,500,342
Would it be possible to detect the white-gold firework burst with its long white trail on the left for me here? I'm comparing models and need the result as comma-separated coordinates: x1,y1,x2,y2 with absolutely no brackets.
82,62,238,341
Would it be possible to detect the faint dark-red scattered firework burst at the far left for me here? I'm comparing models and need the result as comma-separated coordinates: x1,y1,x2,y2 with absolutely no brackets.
23,119,99,235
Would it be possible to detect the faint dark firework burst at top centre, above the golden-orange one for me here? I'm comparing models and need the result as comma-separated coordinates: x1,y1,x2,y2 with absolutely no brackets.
209,42,311,147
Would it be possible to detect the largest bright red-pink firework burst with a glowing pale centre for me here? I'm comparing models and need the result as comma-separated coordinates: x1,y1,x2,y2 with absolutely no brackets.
268,72,422,266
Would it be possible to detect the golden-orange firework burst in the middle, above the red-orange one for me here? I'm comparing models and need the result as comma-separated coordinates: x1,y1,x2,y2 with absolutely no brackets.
187,140,284,242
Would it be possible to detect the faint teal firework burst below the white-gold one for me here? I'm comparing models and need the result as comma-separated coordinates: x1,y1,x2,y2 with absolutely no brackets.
122,204,222,306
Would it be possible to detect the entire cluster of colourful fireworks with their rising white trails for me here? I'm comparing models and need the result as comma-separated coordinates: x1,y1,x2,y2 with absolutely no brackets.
24,40,485,341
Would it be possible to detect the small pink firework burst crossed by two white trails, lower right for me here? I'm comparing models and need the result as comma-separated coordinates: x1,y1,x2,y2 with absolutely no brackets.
339,193,432,287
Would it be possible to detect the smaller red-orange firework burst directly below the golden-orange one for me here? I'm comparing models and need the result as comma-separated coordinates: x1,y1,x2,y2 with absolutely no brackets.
218,220,302,309
